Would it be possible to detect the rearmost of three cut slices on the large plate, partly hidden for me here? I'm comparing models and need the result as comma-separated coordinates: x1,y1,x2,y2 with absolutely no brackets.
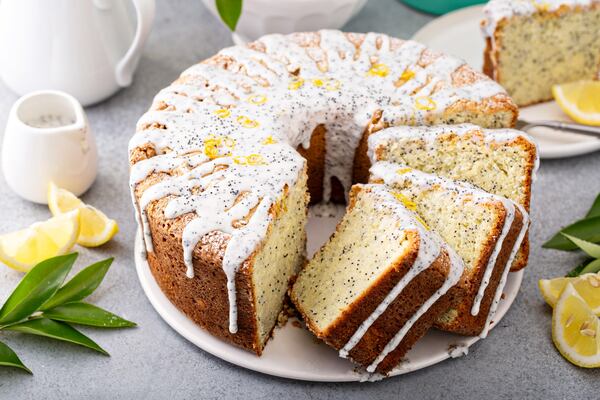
368,124,539,271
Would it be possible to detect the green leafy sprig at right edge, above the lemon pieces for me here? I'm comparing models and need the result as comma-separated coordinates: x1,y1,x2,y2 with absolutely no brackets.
543,194,600,277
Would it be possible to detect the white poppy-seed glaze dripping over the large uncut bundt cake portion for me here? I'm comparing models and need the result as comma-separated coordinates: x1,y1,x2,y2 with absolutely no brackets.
129,31,505,332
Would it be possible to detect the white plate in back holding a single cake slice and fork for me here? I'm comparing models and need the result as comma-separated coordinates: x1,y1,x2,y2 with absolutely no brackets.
413,6,600,158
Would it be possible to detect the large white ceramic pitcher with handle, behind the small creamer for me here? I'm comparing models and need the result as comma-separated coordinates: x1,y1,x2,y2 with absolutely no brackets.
0,0,155,105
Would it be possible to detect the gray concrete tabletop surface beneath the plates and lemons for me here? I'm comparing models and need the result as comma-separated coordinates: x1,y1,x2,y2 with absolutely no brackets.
0,0,600,400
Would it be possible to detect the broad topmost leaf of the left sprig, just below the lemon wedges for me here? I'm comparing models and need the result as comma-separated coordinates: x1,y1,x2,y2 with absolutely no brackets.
0,253,77,325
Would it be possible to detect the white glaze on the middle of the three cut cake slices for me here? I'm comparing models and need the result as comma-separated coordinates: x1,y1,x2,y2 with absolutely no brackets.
370,161,529,332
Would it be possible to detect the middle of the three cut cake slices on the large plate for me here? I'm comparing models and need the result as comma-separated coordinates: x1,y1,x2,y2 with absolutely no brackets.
371,162,528,337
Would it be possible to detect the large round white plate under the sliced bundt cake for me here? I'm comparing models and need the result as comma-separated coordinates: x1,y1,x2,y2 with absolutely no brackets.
135,207,523,382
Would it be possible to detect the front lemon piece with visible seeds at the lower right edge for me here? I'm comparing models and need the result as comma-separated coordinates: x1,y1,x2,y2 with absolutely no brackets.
552,282,600,368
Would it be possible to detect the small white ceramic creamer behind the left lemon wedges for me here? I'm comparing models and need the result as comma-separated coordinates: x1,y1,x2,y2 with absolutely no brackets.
2,90,98,204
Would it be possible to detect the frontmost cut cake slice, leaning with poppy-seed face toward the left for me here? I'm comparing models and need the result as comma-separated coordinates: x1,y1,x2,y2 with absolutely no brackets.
291,185,463,374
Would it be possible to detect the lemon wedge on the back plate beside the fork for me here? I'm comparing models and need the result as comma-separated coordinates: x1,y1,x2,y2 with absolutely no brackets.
552,81,600,126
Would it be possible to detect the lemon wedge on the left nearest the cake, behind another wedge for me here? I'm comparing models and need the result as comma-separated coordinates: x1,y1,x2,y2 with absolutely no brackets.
48,183,119,247
